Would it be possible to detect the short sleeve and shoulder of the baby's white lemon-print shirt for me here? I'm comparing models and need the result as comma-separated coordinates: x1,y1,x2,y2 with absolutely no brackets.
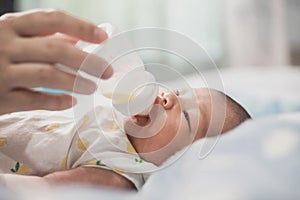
66,107,158,189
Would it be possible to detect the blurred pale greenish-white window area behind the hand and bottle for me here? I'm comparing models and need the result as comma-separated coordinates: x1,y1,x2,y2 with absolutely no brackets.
15,0,224,72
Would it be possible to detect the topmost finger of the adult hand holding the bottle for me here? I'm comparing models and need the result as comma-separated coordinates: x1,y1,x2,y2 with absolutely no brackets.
11,10,107,42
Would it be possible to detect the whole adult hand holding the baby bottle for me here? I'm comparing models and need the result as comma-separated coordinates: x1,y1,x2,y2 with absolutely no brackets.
0,10,113,114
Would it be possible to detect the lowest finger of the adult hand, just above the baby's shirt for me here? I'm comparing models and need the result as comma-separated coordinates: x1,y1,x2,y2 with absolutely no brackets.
0,88,76,114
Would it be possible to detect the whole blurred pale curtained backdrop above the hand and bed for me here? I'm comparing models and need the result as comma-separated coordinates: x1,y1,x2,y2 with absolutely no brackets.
0,0,300,68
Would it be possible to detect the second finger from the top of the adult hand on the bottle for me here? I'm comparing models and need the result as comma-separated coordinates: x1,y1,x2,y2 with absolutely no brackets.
11,37,113,79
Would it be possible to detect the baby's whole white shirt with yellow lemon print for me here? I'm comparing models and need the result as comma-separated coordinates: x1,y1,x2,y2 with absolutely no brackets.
0,106,157,189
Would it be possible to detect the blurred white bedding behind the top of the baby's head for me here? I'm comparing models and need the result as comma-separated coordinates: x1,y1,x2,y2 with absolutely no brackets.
188,66,300,118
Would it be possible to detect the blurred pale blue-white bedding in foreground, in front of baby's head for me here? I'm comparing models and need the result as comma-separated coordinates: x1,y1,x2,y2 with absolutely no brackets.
139,112,300,200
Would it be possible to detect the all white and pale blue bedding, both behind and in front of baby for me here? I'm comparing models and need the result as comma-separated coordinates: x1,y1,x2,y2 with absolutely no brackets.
0,68,300,200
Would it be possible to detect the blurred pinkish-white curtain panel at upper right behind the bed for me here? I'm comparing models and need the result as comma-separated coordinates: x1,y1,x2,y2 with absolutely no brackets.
226,0,289,66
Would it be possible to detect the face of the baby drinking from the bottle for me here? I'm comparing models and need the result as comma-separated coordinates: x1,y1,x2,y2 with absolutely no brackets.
124,89,217,165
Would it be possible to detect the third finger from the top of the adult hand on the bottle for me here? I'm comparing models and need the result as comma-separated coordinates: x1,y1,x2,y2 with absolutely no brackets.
6,63,97,94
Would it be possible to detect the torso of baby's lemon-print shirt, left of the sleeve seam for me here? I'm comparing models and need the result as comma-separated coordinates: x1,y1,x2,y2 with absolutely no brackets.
0,111,74,176
